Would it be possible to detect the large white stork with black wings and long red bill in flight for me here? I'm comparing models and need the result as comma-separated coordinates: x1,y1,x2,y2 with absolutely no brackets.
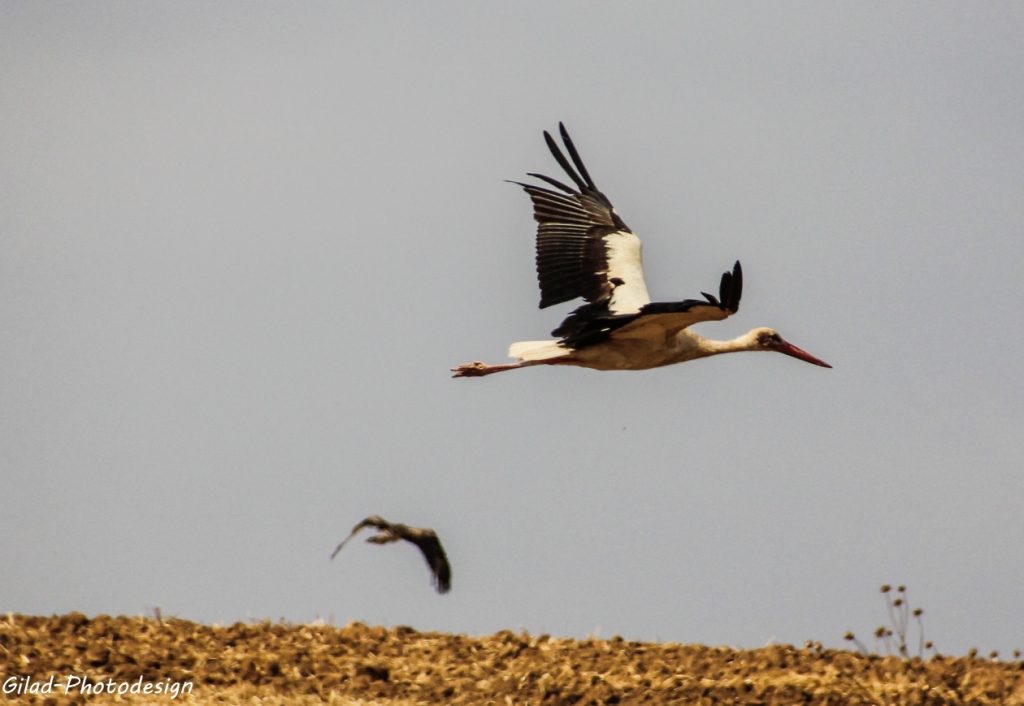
452,123,831,377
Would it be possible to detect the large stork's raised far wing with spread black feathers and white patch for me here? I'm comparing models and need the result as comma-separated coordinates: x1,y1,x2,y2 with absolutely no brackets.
515,123,650,315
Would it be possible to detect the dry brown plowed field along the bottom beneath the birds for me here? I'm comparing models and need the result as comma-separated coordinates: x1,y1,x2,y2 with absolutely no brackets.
0,613,1024,706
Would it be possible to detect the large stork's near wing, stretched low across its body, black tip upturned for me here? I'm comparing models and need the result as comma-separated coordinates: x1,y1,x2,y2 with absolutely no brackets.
563,261,743,350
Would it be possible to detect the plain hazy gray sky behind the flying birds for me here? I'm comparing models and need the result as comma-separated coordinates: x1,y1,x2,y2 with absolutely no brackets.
0,2,1024,653
